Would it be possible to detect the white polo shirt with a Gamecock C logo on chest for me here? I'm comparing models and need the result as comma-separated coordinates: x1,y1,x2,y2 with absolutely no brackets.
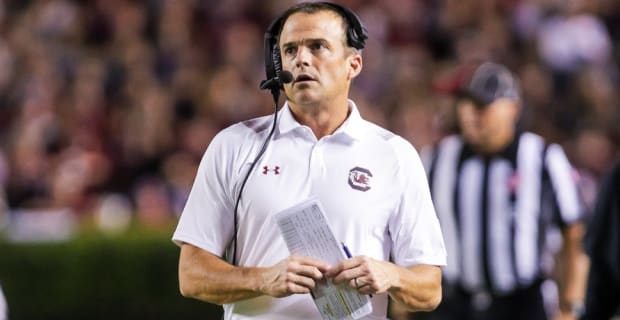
173,101,446,320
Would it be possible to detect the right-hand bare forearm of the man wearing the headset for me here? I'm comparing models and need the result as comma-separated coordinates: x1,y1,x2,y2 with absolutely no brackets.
388,265,441,311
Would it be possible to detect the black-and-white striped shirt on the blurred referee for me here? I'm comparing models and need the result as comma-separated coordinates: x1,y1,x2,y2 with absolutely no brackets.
424,133,582,294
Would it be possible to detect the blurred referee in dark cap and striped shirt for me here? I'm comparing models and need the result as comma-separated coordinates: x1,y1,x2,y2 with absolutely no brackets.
424,62,587,320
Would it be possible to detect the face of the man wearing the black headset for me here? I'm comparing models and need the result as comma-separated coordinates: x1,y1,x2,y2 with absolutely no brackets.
279,11,362,105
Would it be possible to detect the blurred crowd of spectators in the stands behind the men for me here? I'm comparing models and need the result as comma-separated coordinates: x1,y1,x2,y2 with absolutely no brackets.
0,0,620,239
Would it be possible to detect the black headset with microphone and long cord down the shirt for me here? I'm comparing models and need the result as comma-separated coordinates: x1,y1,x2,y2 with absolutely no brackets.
227,1,368,265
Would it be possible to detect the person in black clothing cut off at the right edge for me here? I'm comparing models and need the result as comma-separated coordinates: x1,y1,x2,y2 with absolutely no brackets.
584,161,620,319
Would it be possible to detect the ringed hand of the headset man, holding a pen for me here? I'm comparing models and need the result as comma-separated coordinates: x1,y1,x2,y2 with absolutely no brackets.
325,256,398,294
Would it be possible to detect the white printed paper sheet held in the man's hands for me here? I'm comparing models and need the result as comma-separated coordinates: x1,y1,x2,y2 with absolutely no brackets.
275,199,372,320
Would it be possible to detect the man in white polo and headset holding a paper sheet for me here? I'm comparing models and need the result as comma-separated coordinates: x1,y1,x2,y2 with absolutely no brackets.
173,2,445,319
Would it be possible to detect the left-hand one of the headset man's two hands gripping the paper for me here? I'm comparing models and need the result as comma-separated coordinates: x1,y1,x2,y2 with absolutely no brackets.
261,255,329,298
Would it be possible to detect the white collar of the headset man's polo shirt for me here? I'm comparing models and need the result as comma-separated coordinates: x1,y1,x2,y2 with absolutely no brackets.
278,100,364,140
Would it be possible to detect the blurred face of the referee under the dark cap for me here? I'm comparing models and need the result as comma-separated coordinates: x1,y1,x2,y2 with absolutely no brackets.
456,99,519,152
